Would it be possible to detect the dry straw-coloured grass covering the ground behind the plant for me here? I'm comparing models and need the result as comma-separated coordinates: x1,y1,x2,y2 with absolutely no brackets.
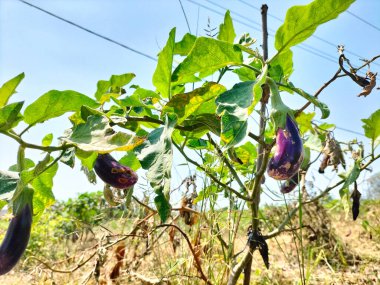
0,202,380,285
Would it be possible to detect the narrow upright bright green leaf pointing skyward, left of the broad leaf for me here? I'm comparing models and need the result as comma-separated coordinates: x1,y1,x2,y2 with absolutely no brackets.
153,28,176,98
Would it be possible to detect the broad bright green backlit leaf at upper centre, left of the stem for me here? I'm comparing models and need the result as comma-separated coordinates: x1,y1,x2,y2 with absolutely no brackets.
172,37,243,84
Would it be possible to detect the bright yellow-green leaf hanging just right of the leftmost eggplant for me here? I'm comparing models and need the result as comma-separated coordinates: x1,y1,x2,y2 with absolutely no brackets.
31,159,58,217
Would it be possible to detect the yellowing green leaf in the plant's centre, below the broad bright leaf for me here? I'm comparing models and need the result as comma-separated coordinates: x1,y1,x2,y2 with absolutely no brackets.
162,82,226,124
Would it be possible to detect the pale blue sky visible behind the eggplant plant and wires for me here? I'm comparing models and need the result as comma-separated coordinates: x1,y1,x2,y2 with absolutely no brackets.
0,0,380,199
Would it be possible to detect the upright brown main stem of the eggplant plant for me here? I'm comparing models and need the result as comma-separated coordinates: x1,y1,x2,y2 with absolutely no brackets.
243,4,269,285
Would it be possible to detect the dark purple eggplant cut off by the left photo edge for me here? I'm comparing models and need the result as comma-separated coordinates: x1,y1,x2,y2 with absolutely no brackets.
0,203,32,275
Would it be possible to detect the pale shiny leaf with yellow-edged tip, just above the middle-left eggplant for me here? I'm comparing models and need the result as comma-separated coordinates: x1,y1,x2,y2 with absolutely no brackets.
63,115,144,153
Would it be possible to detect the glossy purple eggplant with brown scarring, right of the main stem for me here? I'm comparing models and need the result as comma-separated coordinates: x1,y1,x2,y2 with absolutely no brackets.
268,115,304,180
